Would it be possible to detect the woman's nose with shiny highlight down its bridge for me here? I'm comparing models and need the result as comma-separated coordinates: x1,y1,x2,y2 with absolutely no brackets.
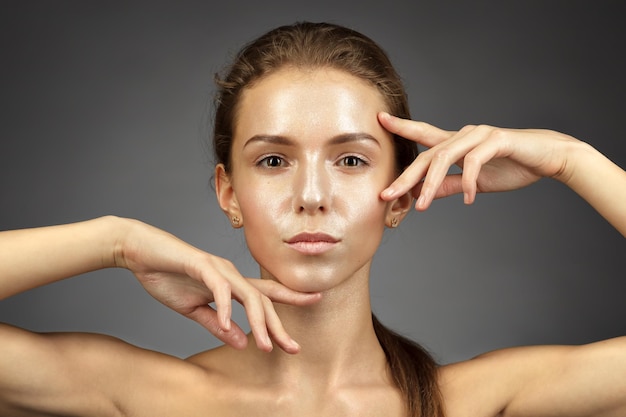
294,161,331,214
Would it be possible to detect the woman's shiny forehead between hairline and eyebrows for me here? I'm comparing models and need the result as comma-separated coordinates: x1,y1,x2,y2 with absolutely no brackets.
233,68,388,141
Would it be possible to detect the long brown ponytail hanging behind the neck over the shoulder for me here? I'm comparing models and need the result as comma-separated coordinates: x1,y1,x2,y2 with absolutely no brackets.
372,314,444,417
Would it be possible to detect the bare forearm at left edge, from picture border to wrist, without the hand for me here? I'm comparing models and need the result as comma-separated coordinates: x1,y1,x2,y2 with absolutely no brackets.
0,216,125,299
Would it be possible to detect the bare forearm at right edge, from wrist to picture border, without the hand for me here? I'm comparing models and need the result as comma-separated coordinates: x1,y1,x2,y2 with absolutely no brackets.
557,142,626,237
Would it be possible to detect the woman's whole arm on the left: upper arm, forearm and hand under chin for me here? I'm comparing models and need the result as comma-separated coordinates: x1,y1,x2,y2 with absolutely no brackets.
0,217,319,416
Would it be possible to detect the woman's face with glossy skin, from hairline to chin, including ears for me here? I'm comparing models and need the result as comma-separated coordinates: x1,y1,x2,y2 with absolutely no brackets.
216,69,410,291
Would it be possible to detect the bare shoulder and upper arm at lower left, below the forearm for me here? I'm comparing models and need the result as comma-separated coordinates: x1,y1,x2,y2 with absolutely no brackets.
0,325,219,417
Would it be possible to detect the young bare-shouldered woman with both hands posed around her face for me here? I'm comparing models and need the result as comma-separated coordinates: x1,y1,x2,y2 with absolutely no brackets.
0,23,626,417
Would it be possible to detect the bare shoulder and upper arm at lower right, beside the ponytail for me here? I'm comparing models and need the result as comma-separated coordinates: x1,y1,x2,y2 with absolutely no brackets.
440,338,626,417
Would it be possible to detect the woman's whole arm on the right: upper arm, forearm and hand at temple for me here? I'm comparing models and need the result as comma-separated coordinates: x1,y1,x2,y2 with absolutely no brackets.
380,114,626,417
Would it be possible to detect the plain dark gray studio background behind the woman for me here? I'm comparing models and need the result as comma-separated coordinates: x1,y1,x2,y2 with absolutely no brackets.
0,0,626,362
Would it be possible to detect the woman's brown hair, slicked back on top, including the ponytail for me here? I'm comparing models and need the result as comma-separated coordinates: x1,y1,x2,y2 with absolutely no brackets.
213,22,443,417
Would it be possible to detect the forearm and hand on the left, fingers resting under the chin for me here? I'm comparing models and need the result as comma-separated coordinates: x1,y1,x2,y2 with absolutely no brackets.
0,216,319,353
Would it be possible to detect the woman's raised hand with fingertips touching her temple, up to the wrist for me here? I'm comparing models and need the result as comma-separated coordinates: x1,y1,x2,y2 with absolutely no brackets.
378,113,580,211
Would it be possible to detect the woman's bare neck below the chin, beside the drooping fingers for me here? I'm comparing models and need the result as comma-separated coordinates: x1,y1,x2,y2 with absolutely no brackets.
244,264,386,386
